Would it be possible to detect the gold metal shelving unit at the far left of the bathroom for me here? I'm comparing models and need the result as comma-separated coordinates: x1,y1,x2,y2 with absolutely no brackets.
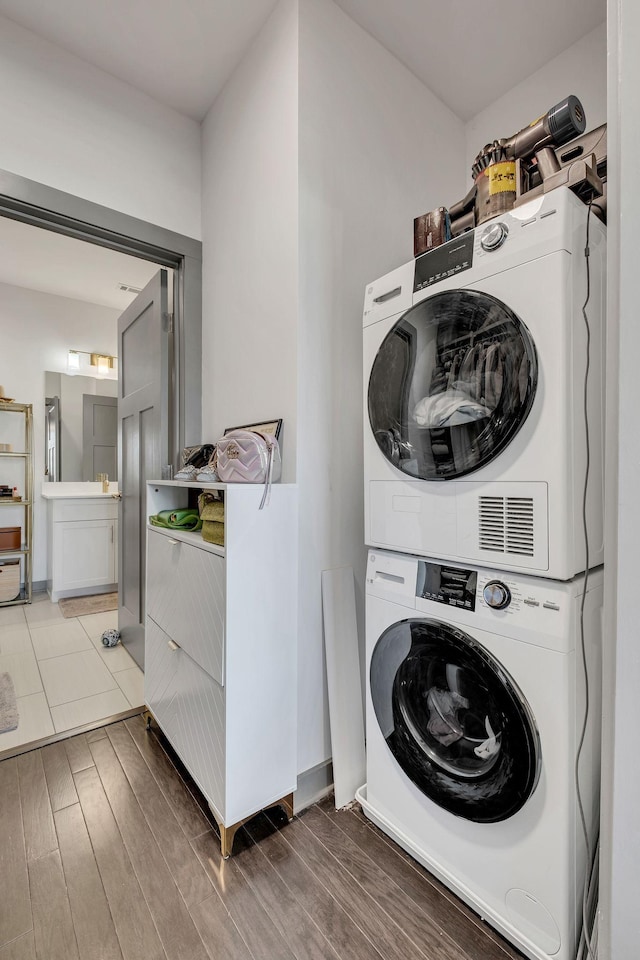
0,402,33,607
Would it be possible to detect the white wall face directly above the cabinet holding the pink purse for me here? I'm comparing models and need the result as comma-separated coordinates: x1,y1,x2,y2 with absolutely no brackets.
202,0,298,481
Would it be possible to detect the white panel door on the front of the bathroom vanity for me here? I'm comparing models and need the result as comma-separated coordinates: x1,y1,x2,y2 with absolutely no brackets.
53,520,116,593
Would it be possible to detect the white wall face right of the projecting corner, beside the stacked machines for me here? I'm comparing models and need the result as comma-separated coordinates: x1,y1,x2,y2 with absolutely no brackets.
298,0,464,770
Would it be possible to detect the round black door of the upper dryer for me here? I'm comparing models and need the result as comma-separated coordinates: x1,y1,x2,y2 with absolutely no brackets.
368,290,538,480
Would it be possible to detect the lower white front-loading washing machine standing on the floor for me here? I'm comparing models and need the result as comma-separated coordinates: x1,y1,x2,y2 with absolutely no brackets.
358,550,603,960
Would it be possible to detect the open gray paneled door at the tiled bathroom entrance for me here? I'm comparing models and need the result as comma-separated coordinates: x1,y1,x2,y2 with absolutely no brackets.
118,270,170,667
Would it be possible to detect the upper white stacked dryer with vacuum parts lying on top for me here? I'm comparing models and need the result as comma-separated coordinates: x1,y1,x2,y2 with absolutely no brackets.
363,188,606,580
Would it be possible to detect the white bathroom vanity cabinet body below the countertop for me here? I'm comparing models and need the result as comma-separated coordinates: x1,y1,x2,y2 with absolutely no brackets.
47,498,118,602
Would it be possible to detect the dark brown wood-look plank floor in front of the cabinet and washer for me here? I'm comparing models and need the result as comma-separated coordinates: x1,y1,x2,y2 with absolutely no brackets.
0,717,520,960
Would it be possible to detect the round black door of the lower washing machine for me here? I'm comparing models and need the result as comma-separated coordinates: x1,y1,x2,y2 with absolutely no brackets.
370,620,540,823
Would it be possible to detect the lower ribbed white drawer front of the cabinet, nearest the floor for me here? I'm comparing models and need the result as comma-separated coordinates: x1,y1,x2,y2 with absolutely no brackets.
144,617,225,819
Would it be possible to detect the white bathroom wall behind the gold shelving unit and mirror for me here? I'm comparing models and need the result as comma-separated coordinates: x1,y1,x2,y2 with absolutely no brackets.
0,283,120,581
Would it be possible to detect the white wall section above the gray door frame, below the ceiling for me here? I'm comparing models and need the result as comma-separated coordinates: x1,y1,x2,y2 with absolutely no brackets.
0,17,200,239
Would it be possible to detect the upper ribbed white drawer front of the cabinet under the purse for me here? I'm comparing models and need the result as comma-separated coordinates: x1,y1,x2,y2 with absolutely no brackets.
147,530,225,685
